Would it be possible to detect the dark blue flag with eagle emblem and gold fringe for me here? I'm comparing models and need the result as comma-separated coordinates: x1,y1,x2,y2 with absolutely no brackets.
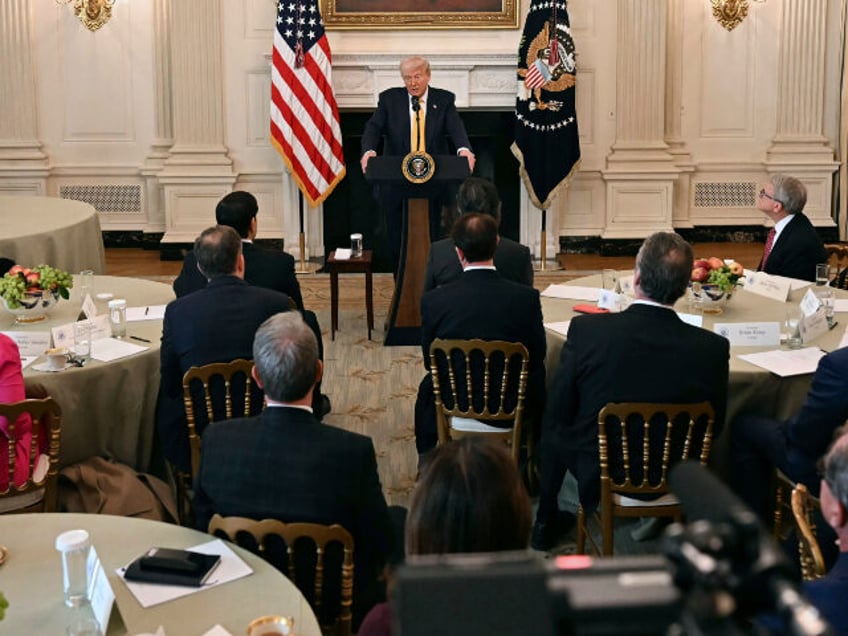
512,0,580,210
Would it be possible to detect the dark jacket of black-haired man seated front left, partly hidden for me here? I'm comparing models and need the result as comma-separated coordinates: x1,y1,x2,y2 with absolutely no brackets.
174,242,303,309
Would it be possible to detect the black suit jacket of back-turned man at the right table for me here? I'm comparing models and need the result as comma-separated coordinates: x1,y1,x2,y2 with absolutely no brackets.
542,303,730,509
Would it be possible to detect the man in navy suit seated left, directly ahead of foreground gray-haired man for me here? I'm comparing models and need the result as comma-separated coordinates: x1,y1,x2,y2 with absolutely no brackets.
156,225,291,473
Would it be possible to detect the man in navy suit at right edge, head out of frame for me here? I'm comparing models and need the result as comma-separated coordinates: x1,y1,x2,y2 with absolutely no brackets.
731,347,848,521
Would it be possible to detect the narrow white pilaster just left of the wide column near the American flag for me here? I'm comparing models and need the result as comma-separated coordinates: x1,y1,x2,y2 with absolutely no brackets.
141,0,174,232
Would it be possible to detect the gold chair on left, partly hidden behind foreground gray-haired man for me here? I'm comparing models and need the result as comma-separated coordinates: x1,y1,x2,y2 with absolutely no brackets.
174,358,253,523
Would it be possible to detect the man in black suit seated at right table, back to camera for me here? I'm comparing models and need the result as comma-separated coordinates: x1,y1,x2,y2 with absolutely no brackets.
532,232,730,550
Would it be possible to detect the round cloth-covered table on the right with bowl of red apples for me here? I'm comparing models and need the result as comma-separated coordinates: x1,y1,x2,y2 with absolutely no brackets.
542,272,848,475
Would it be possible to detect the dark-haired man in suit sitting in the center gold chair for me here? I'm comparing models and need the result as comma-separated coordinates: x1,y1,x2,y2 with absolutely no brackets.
415,213,546,456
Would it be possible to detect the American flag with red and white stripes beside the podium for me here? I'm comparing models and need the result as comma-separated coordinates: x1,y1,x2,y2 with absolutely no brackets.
271,0,345,207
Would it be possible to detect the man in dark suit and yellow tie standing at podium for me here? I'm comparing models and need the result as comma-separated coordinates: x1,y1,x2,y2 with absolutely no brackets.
360,55,474,272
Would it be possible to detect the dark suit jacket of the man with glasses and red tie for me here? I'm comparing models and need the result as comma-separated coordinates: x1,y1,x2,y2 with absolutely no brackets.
757,212,827,281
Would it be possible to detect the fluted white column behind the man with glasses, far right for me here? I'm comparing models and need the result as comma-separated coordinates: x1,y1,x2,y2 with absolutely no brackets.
766,0,838,226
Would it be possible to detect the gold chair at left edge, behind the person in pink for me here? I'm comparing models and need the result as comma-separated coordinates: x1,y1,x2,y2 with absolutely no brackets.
0,397,62,514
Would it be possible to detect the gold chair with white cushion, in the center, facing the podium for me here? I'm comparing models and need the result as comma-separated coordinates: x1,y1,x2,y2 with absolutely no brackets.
430,339,533,464
